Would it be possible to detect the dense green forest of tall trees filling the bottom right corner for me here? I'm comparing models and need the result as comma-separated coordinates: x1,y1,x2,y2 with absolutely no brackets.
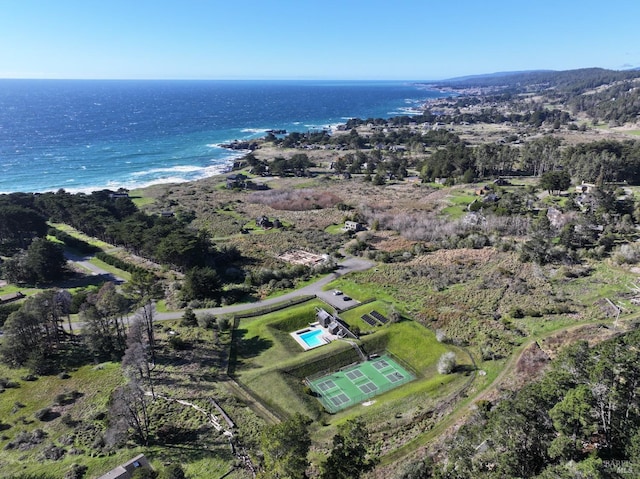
400,331,640,479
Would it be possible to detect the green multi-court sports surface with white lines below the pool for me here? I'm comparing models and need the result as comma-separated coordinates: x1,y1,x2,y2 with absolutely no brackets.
307,354,416,413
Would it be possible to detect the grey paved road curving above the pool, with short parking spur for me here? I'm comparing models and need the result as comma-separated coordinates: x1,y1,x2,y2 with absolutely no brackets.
155,257,375,321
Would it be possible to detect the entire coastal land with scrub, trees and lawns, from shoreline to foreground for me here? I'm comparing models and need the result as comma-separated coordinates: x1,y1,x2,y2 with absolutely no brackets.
0,69,640,479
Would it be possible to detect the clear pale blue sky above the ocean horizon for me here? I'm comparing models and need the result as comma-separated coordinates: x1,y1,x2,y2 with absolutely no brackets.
0,0,640,80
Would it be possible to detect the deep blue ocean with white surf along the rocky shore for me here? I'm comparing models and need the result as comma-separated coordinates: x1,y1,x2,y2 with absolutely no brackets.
0,80,446,193
